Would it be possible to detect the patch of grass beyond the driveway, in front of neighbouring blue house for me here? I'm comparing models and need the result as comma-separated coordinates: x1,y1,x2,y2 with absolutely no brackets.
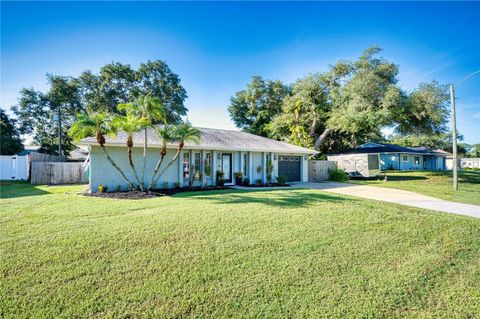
348,170,480,205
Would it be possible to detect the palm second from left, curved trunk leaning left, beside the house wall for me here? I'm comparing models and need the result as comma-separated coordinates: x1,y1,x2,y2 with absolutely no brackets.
112,103,150,192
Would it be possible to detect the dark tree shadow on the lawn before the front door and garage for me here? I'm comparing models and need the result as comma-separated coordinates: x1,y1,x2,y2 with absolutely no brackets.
174,189,356,208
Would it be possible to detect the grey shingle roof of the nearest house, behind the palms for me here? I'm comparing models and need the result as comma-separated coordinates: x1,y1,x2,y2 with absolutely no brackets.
78,127,315,154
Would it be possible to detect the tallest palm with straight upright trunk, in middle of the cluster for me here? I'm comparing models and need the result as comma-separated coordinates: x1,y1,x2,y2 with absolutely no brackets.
133,94,166,189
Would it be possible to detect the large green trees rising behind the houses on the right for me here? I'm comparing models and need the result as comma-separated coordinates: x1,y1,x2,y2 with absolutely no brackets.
228,47,476,154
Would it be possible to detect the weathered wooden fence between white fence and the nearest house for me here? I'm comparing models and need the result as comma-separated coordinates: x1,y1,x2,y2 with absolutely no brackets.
30,162,88,185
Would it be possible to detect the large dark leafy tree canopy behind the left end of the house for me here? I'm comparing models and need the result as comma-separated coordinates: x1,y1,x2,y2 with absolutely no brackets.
12,60,187,155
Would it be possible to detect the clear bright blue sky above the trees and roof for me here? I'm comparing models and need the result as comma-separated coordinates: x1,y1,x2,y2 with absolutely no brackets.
0,1,480,143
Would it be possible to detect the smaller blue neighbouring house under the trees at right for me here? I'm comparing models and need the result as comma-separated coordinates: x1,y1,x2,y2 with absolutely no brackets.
328,142,446,176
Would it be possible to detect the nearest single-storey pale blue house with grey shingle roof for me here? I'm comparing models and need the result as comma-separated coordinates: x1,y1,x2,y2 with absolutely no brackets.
78,128,314,192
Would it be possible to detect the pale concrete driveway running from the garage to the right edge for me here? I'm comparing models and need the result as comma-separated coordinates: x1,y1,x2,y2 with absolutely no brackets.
292,182,480,218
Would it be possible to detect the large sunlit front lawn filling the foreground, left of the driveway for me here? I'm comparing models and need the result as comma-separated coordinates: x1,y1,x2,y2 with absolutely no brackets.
0,183,480,318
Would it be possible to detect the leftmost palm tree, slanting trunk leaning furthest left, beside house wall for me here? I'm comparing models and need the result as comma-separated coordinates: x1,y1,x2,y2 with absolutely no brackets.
69,112,133,189
